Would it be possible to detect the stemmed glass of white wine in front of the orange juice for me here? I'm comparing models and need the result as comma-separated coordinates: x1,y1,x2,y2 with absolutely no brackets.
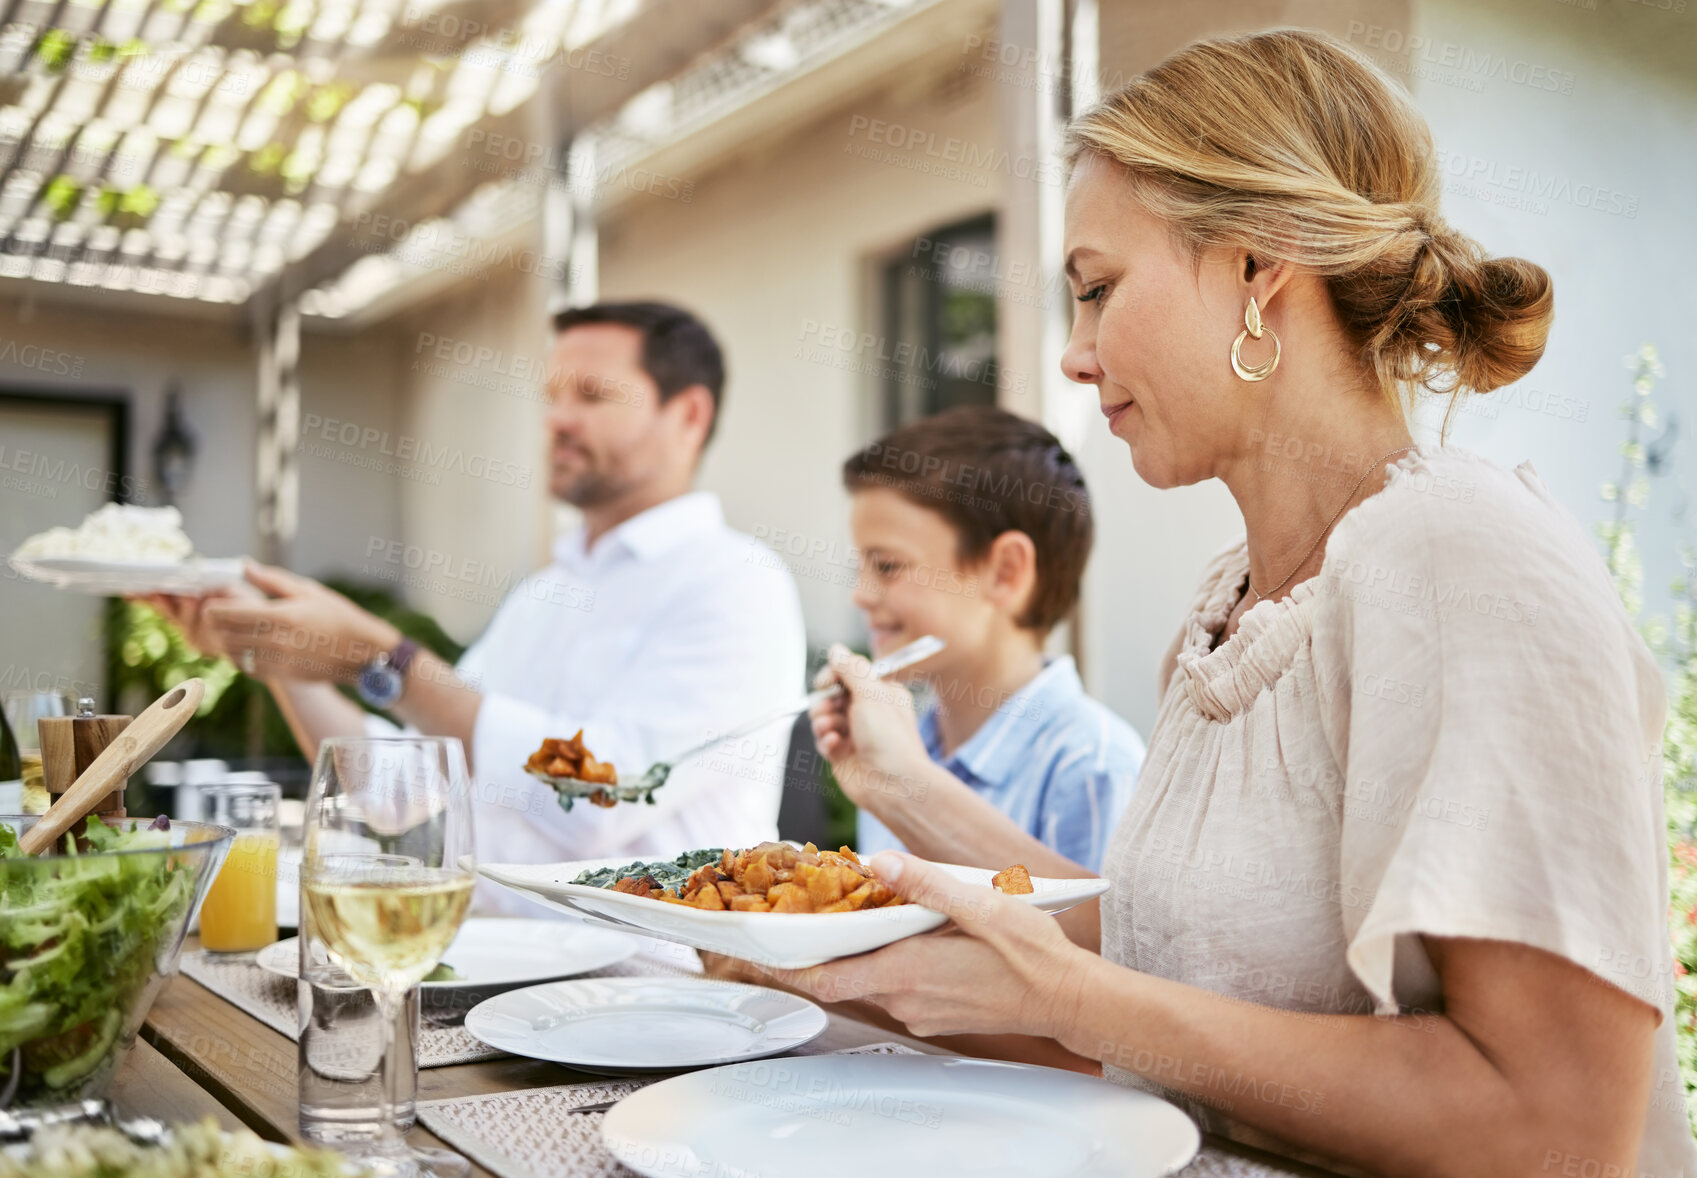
300,737,473,1178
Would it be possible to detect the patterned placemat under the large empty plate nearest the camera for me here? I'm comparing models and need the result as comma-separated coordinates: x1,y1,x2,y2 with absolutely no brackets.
417,1044,1291,1178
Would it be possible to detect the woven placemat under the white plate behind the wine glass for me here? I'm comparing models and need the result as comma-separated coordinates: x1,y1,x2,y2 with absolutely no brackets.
178,937,701,1068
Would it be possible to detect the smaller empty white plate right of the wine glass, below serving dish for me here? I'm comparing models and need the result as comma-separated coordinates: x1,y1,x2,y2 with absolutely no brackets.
465,978,825,1073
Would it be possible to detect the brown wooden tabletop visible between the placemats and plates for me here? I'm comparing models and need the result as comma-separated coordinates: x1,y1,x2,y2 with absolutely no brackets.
123,976,1334,1178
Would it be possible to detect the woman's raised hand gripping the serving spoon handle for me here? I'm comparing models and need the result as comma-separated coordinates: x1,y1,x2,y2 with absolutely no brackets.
811,645,932,813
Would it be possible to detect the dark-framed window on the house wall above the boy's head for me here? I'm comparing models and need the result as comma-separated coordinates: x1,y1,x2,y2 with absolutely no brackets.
882,214,996,429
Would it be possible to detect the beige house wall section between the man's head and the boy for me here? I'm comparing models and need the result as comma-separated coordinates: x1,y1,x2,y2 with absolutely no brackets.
601,36,1005,655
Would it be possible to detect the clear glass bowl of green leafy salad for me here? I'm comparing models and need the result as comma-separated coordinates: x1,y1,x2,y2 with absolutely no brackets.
0,815,236,1108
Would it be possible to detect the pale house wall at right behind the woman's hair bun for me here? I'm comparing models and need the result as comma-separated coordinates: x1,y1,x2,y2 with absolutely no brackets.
1391,0,1697,628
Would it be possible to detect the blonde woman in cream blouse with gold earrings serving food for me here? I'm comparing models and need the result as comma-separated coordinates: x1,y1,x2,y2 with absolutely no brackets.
787,32,1697,1178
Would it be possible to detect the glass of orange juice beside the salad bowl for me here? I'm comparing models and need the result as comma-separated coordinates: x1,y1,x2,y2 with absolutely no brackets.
200,783,282,956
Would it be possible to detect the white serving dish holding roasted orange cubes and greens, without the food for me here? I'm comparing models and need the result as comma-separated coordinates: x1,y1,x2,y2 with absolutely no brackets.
477,857,1108,969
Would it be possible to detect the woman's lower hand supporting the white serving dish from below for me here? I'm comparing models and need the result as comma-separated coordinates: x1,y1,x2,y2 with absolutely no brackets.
765,850,1100,1039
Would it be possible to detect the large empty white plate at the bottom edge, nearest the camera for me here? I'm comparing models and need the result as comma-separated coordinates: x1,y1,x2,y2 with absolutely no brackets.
601,1056,1201,1178
